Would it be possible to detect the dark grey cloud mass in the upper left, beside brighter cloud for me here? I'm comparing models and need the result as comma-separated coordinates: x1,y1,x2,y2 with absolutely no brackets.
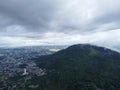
0,0,60,29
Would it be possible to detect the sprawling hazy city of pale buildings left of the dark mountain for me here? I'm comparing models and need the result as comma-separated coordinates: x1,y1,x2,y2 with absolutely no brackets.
0,46,63,77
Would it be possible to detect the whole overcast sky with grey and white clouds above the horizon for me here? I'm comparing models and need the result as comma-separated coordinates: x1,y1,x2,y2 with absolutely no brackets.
0,0,120,51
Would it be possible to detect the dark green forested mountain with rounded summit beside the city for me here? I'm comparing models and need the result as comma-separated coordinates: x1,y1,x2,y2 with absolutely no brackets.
36,44,120,90
